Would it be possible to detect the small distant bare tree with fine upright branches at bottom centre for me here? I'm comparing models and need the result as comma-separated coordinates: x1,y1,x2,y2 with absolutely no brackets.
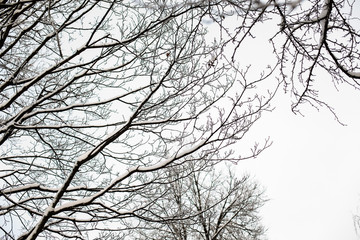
131,165,265,240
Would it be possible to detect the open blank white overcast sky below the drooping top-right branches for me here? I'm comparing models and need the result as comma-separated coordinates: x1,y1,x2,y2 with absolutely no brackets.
237,83,360,240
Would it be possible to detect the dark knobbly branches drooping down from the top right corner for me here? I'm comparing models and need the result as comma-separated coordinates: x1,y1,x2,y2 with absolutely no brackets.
271,0,360,118
